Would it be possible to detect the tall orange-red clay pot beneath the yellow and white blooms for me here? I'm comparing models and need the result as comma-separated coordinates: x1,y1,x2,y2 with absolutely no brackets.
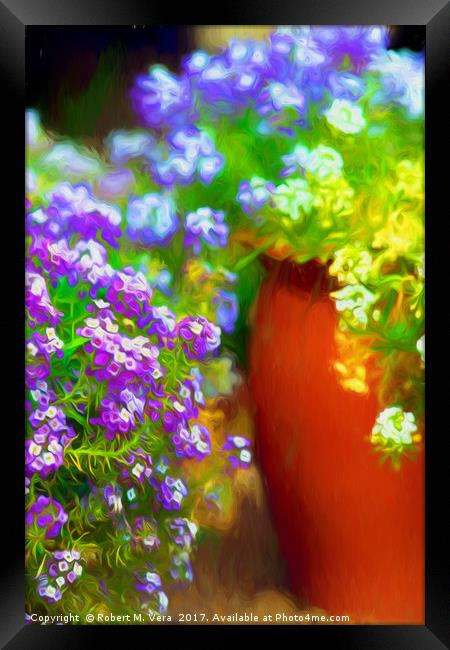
250,262,424,624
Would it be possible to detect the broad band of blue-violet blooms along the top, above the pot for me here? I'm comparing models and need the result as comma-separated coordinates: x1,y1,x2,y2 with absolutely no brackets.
132,26,398,139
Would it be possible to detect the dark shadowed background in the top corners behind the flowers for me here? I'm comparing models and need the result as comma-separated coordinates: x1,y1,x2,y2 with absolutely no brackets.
26,25,425,145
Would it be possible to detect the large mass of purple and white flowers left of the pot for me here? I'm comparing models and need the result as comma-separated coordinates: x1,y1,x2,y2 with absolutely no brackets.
25,152,224,611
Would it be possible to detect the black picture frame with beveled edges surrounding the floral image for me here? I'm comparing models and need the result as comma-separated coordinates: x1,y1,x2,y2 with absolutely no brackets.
0,0,450,650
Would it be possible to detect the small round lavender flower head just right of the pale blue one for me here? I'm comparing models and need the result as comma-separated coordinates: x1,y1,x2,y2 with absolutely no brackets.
184,208,229,253
